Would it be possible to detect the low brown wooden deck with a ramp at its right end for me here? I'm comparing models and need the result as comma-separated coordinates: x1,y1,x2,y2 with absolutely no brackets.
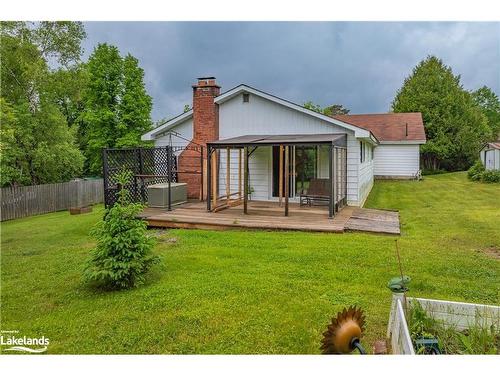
141,201,400,234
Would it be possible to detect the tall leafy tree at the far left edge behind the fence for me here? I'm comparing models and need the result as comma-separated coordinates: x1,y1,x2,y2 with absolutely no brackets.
0,22,85,186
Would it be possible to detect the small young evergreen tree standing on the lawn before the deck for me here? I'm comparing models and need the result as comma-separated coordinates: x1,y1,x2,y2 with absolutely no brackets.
84,173,159,289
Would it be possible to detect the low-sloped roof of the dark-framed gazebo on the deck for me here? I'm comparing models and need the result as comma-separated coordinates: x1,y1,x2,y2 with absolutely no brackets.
208,134,347,148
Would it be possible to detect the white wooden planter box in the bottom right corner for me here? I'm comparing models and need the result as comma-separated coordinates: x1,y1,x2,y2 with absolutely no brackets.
387,294,500,354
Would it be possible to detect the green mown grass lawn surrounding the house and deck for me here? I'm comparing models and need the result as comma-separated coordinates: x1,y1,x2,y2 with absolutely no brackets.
1,173,500,353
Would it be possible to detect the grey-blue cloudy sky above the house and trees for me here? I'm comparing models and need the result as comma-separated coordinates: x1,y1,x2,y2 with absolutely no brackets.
84,22,500,120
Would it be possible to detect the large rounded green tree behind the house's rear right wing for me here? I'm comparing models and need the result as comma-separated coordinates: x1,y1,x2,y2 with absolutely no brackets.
392,56,490,170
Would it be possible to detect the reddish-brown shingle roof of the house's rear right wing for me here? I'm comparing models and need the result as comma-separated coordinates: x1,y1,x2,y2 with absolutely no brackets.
333,112,425,142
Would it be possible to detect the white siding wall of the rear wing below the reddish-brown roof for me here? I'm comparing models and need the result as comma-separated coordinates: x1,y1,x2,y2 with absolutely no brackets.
374,144,420,178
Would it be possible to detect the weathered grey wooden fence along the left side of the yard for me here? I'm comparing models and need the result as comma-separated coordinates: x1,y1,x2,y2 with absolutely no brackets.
0,179,104,221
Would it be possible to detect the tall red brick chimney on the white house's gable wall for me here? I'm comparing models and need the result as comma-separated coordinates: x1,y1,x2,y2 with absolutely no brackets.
178,77,220,199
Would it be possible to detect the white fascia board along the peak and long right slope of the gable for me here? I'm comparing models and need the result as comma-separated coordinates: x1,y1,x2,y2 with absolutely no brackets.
215,85,372,139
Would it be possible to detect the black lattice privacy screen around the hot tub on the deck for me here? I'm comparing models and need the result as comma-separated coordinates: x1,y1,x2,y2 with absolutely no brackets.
103,146,203,208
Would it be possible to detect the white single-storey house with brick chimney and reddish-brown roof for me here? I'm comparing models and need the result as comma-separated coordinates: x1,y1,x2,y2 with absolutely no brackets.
142,77,426,212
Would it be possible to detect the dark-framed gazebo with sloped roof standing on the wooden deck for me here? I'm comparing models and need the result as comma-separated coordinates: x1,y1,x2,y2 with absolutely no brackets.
207,134,347,217
